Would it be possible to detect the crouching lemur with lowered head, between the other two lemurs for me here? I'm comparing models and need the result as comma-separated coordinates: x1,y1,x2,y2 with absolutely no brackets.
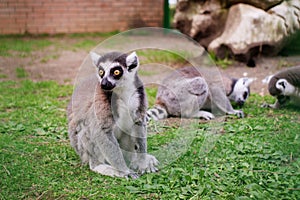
147,67,254,121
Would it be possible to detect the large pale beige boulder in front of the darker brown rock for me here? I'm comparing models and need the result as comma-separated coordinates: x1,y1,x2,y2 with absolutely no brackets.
208,0,300,66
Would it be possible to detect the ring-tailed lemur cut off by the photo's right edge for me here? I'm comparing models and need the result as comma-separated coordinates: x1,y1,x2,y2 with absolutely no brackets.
262,66,300,108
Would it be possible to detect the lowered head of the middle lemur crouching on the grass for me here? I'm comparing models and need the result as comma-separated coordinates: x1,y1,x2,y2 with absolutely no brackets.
228,77,254,106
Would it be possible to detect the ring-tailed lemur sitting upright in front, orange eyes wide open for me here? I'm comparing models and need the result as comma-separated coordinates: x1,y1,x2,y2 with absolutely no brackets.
67,52,158,178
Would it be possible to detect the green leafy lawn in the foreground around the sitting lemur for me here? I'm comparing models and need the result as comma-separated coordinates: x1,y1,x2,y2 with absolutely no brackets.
0,80,300,199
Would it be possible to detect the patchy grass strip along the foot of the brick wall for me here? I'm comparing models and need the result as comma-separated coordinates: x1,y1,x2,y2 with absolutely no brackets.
0,32,117,58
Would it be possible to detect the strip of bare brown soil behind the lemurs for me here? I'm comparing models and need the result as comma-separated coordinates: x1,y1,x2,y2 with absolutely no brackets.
0,37,300,95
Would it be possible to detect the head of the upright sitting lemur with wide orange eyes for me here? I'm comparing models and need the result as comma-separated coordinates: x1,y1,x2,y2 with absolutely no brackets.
90,52,139,90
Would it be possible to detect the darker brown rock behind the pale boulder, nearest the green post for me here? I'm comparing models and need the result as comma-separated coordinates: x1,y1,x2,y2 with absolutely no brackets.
174,0,227,48
